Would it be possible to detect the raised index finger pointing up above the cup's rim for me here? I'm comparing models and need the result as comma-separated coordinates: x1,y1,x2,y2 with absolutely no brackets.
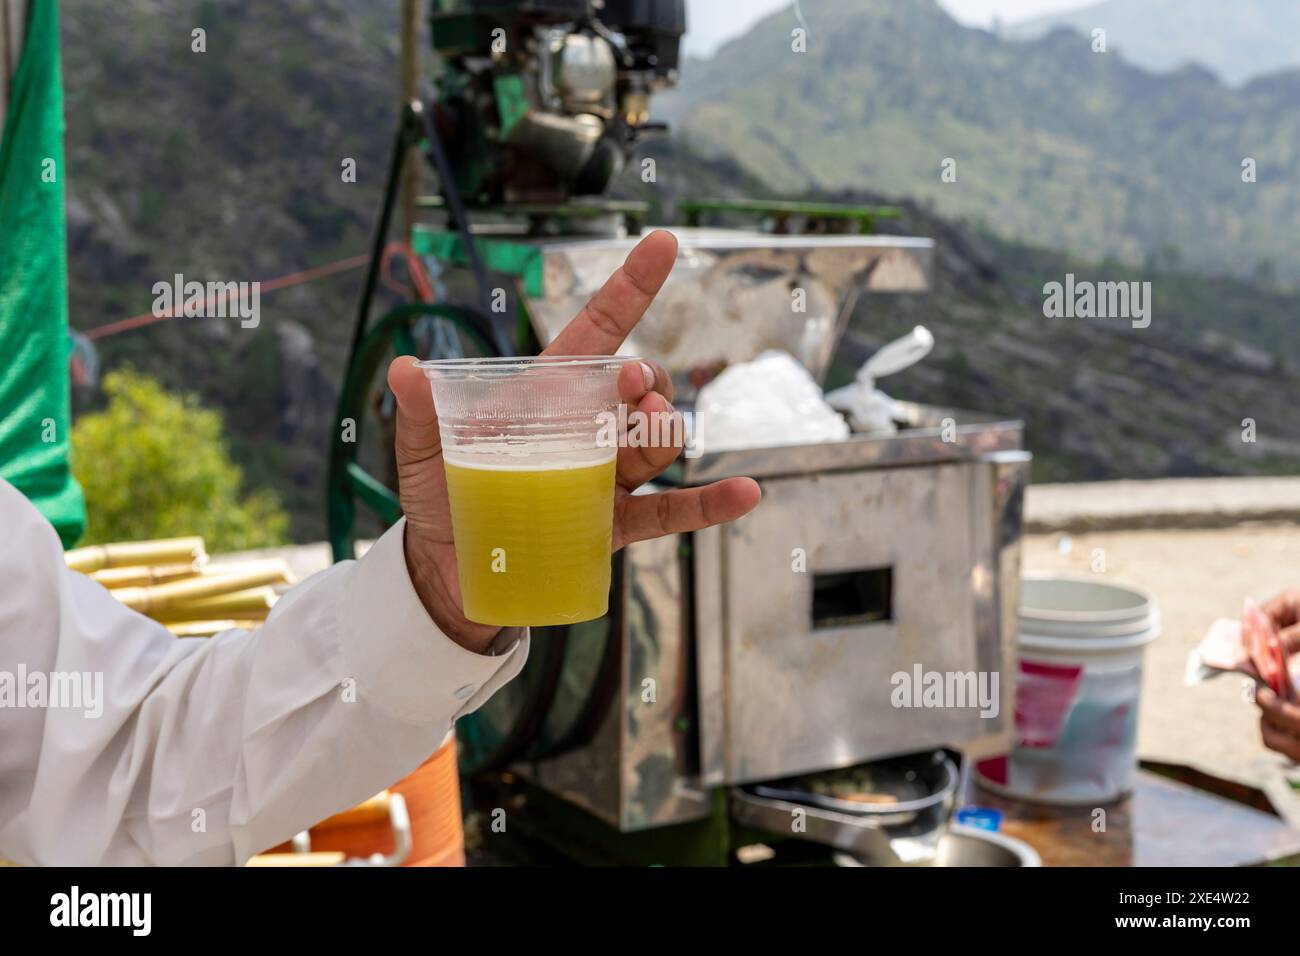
542,229,677,355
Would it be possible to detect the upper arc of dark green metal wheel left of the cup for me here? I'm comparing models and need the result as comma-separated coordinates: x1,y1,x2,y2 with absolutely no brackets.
328,302,497,561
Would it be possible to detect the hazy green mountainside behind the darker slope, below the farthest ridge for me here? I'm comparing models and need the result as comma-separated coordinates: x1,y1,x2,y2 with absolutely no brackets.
663,0,1300,280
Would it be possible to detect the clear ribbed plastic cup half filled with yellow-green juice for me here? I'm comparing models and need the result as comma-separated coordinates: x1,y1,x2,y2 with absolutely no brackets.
419,355,636,627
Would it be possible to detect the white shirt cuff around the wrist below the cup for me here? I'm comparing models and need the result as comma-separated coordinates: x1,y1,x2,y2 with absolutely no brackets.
338,518,520,723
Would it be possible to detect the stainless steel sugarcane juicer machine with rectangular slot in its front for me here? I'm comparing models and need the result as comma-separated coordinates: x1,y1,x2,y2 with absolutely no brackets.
441,229,1028,862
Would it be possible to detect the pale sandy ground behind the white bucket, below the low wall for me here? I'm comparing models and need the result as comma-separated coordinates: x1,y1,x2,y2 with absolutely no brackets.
1023,524,1300,786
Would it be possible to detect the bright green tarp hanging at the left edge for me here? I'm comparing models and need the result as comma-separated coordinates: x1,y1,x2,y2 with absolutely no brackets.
0,0,86,546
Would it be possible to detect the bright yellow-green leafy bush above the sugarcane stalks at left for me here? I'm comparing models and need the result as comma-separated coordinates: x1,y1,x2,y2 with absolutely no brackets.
73,369,289,551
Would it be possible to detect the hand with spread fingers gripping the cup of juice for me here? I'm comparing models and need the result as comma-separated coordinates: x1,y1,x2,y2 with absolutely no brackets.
389,232,759,652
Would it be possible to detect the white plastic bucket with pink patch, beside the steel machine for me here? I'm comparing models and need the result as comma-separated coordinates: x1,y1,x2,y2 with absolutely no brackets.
1004,578,1160,805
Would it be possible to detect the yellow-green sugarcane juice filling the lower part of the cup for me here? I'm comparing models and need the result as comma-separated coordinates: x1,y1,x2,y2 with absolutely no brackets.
446,449,615,627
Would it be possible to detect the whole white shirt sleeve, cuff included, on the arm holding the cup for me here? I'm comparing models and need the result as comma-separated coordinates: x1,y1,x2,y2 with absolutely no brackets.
0,481,528,865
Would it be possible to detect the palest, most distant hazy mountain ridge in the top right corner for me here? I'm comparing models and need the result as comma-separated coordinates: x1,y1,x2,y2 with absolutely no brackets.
1004,0,1300,86
